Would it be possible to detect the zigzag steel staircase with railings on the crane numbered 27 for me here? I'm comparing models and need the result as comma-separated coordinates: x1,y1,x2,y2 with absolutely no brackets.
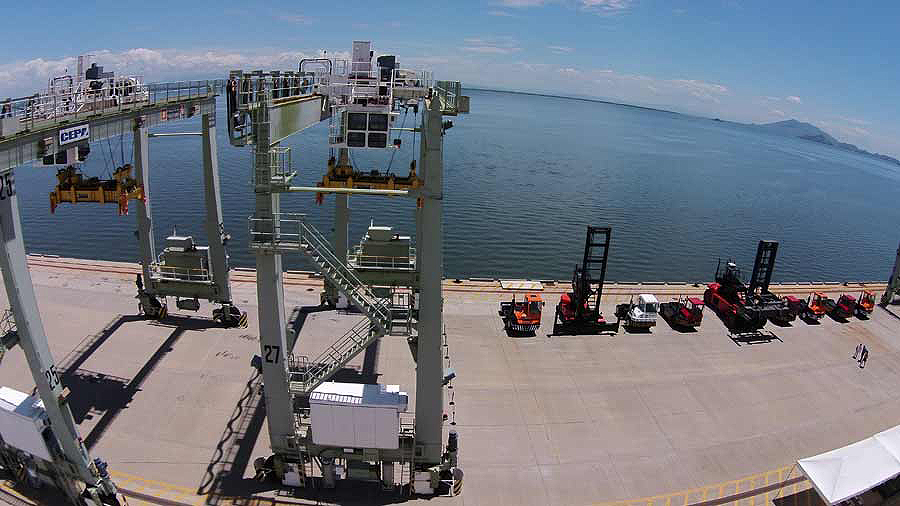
250,213,391,395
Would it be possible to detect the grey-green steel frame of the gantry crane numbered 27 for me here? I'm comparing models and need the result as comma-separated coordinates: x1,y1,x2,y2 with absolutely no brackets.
226,41,461,490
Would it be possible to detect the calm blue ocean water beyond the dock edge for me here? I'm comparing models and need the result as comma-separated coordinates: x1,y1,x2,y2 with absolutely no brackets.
16,90,900,281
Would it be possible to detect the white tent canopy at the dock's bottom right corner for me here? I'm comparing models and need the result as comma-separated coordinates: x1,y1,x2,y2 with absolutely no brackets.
797,425,900,504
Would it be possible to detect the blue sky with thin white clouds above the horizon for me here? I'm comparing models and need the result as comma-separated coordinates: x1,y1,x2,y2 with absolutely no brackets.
0,0,900,156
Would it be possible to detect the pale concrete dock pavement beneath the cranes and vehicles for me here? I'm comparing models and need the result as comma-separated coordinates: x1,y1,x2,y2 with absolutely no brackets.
0,256,900,506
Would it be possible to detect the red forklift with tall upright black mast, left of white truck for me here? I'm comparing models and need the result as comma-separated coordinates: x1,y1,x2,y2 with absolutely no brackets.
552,226,619,336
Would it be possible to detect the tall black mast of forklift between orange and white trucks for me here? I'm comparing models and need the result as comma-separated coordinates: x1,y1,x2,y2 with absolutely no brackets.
572,226,612,319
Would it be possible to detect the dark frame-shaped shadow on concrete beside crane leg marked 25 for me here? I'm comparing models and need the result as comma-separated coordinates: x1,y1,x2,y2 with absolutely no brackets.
60,315,219,449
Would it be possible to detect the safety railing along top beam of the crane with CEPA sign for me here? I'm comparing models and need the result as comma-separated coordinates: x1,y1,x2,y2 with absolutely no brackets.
0,79,224,137
